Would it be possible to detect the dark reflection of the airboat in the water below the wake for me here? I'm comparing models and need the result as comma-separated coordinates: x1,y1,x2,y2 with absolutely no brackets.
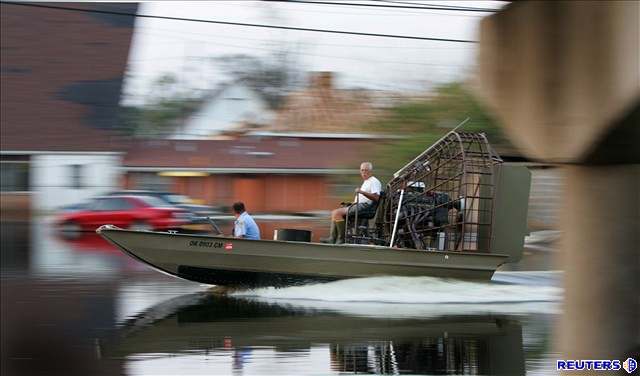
113,293,524,375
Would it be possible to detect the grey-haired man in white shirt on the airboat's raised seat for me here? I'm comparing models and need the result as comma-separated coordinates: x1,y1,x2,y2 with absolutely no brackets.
329,162,382,244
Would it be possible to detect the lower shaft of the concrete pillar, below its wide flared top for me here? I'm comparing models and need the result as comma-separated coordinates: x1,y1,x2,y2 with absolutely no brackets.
559,165,640,360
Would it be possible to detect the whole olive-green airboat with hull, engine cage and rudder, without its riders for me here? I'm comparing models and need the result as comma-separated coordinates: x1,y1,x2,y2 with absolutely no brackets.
96,128,531,287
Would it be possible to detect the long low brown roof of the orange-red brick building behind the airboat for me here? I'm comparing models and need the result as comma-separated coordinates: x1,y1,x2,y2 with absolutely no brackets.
123,137,380,173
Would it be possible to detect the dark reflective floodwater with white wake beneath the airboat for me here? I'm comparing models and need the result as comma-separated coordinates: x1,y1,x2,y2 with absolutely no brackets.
1,218,563,375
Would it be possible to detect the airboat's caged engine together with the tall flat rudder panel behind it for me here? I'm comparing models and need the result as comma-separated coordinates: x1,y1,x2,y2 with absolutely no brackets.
377,130,531,262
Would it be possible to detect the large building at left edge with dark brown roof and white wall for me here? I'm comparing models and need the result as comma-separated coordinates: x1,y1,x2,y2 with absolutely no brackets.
0,3,137,213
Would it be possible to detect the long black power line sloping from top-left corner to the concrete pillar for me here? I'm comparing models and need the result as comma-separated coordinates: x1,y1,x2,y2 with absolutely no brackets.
1,1,478,43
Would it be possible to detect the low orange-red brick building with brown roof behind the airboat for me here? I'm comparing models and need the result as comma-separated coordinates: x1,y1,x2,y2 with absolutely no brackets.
123,135,380,213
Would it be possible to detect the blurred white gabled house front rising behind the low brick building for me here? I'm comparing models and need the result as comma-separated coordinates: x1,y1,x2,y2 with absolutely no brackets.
170,81,274,140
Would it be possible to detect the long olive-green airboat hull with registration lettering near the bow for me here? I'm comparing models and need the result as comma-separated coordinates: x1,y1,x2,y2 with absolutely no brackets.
98,226,507,287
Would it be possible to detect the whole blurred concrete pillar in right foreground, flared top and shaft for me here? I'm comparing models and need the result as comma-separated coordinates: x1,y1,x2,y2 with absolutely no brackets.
479,1,640,366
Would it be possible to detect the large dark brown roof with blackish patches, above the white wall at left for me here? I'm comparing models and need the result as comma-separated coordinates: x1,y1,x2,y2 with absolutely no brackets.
0,3,137,151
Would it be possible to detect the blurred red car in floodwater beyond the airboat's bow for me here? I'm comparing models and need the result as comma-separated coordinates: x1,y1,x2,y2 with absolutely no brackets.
57,196,191,232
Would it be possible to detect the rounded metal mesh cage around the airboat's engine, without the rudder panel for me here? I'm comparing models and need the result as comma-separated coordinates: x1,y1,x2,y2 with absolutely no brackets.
376,131,502,252
